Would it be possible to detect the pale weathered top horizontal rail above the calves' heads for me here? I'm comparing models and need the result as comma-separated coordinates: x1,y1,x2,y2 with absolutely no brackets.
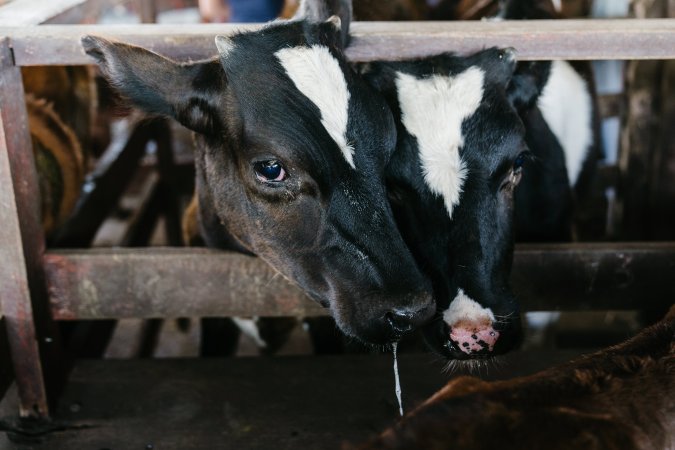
0,19,675,66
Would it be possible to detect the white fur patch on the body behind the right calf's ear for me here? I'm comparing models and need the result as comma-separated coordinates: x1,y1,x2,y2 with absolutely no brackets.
538,61,593,186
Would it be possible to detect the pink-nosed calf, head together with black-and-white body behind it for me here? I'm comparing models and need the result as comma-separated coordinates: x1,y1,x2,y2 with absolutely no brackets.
360,0,599,359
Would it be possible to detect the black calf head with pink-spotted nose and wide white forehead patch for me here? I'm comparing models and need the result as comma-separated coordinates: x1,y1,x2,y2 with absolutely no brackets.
360,49,548,359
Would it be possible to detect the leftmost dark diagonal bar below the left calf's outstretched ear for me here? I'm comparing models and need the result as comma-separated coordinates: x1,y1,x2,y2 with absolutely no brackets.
52,120,158,247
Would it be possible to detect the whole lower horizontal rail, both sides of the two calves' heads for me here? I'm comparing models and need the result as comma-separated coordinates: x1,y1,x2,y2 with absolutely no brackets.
45,243,675,320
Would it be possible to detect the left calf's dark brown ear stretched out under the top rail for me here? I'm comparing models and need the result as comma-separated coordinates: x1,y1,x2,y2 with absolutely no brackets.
81,36,225,134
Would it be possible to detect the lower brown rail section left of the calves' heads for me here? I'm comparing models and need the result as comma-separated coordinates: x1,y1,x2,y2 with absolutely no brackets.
45,248,324,320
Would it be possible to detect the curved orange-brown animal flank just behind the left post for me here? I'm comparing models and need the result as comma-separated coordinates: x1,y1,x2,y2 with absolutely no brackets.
26,95,84,234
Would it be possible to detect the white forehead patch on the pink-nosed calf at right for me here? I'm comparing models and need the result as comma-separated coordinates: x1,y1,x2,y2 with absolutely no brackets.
396,67,485,217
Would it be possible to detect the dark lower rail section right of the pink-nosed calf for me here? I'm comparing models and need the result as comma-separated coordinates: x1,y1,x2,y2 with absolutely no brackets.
511,242,675,311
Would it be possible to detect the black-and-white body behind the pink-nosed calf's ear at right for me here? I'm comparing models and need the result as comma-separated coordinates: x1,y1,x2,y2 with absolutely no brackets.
496,0,602,242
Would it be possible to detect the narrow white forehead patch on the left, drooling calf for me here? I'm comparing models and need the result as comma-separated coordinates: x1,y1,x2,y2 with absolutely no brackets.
275,45,355,168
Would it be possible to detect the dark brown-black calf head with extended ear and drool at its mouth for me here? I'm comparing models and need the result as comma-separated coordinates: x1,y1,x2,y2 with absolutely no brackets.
83,12,434,343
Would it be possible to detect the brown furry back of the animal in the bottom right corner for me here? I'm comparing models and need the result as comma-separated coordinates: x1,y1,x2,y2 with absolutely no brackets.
358,305,675,450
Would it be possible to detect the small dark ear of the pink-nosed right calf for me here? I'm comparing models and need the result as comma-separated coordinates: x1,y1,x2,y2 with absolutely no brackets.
507,61,551,110
